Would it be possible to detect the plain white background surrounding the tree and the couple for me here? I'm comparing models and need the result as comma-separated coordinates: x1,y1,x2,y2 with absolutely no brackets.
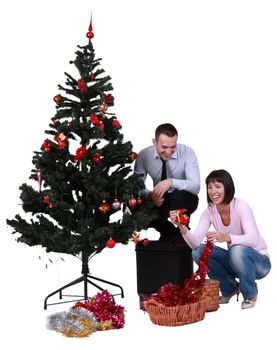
0,0,277,350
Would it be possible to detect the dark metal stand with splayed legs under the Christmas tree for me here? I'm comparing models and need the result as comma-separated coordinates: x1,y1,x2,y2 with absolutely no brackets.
44,251,124,310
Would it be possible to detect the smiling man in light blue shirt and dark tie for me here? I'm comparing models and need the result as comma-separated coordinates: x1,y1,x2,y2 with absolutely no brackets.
135,123,200,242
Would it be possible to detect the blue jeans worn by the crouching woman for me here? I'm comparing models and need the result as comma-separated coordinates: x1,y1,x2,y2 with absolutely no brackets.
192,244,271,299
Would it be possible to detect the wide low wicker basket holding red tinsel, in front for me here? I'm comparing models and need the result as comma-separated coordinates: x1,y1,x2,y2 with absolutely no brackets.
144,298,206,326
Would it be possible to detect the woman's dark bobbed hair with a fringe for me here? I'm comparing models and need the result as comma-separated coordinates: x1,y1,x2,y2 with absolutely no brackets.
206,169,235,204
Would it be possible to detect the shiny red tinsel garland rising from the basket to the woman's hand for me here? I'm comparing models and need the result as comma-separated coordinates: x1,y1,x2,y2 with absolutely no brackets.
155,242,214,306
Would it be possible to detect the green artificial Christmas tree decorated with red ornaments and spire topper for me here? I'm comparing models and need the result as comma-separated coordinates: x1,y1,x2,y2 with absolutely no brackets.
7,22,155,306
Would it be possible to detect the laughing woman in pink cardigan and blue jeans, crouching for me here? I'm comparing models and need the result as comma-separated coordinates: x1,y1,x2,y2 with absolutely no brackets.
170,170,271,309
